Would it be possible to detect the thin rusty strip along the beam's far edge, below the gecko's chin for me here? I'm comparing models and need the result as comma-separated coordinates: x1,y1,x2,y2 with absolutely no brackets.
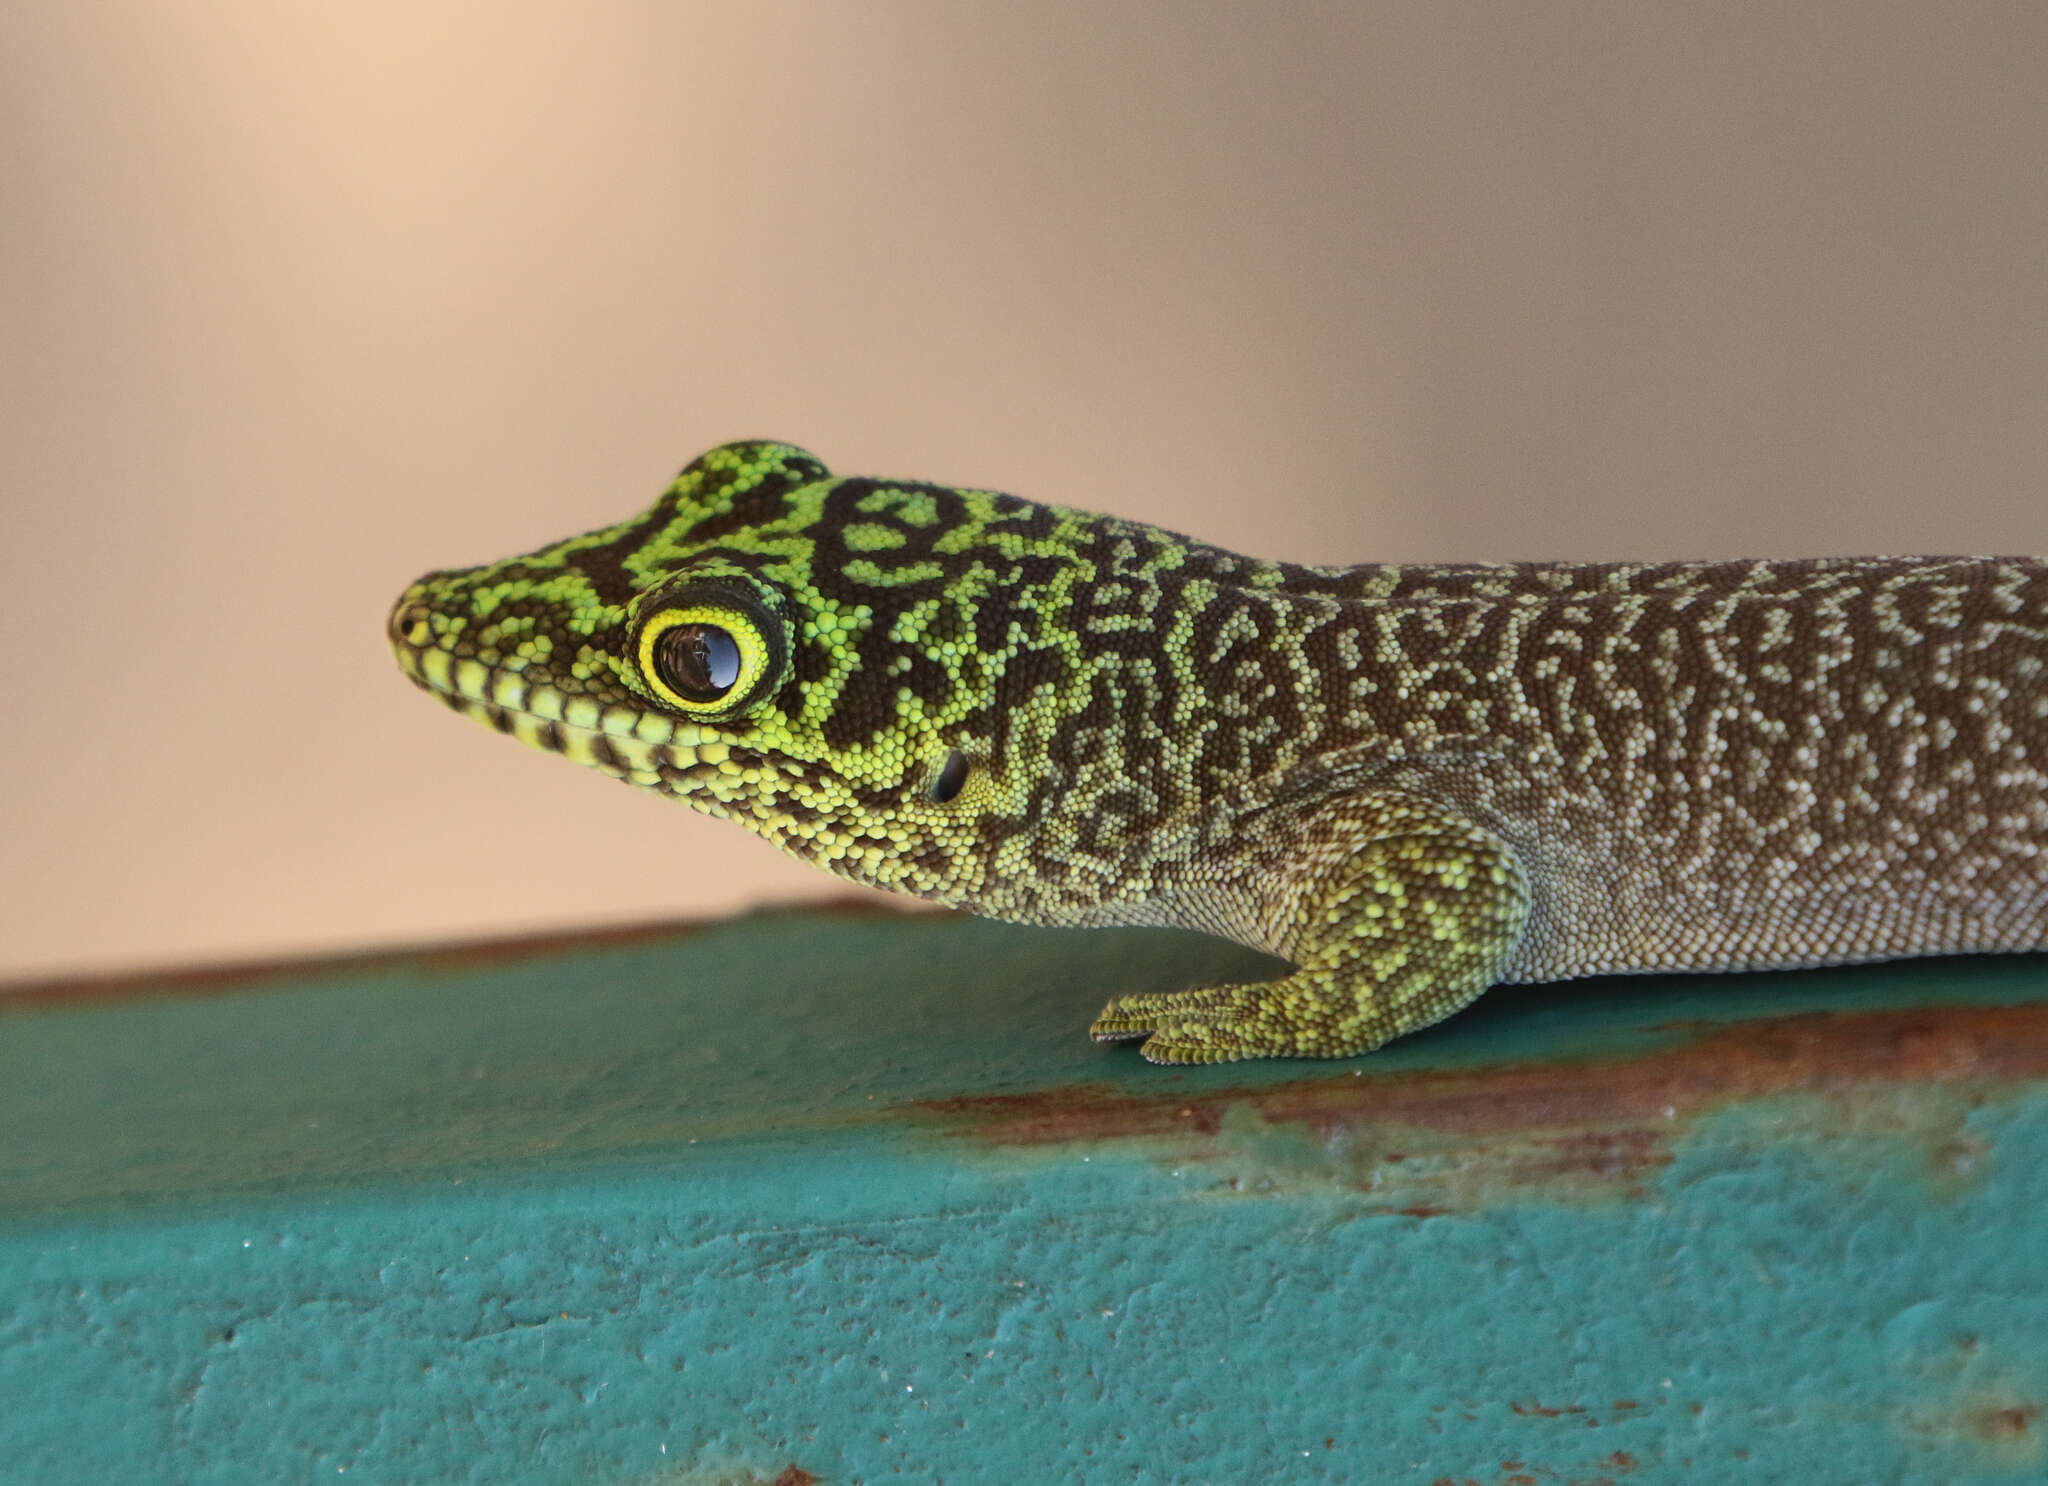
0,899,913,1013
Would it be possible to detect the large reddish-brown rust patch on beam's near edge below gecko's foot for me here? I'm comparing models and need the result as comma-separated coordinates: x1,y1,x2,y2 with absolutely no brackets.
907,1005,2048,1218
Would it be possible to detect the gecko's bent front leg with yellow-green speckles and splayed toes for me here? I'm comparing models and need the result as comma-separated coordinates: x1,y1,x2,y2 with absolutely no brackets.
1090,792,1530,1062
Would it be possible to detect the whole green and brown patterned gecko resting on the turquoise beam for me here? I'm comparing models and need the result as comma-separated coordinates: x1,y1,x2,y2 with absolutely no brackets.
389,442,2048,1062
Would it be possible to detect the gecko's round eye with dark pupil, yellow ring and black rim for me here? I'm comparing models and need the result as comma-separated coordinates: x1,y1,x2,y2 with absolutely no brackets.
635,585,788,718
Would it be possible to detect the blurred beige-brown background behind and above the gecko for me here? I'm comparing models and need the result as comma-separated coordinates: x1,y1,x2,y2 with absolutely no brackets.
0,0,2048,976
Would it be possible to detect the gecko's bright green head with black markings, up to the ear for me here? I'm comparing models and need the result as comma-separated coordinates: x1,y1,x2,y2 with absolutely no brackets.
389,442,1122,903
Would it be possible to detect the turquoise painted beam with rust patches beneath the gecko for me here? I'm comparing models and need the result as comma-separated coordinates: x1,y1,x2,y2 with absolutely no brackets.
0,915,2048,1486
